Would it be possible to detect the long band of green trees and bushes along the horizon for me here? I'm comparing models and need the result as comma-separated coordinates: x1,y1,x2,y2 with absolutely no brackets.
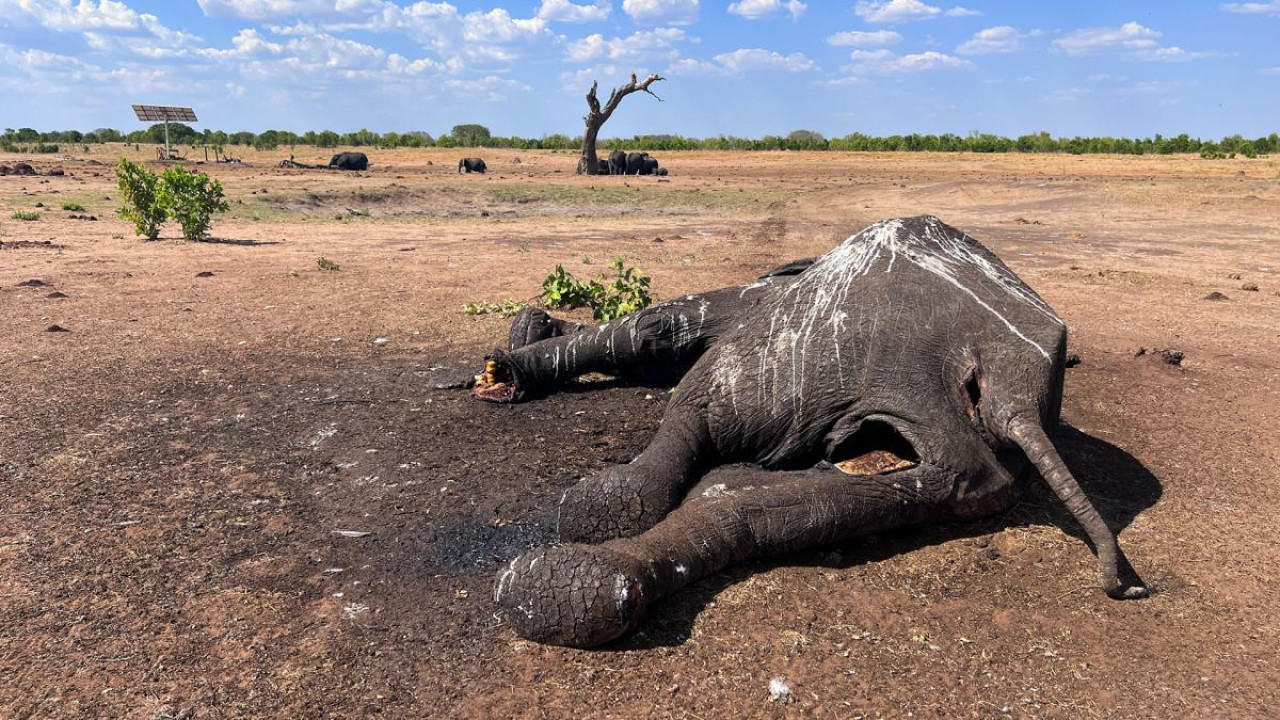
0,123,1280,158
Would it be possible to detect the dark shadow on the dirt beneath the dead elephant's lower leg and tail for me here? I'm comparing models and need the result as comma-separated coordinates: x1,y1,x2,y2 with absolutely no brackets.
605,423,1162,650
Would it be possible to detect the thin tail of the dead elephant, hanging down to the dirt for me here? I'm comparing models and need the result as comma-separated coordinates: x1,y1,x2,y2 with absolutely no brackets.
1009,415,1147,600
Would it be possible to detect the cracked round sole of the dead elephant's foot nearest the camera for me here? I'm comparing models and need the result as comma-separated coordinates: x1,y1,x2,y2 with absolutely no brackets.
494,544,654,647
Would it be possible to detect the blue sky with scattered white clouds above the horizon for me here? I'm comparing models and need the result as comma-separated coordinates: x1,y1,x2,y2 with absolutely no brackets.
0,0,1280,136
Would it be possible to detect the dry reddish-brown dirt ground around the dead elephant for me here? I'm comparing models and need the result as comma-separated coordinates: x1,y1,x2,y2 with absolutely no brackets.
0,142,1280,720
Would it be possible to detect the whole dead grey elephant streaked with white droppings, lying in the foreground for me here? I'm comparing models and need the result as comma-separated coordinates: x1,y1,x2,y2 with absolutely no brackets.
477,217,1146,647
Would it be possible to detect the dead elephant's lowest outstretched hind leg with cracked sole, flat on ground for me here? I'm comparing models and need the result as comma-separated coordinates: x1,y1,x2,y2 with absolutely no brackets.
494,465,1011,647
